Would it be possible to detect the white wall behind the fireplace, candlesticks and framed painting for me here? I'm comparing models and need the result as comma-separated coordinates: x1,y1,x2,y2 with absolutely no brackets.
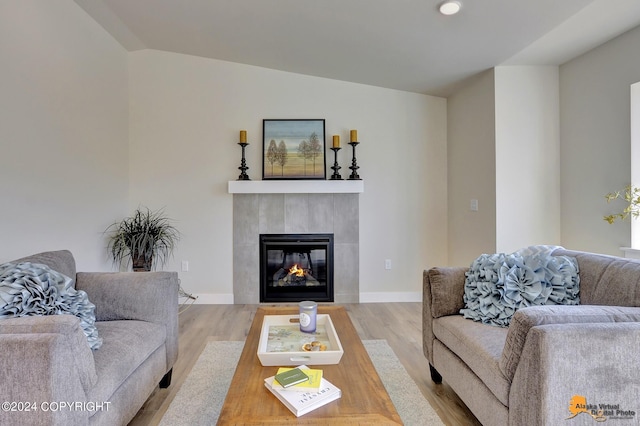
129,50,447,302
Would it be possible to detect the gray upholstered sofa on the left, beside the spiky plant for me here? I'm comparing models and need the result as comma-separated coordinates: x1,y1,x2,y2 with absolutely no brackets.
0,250,178,426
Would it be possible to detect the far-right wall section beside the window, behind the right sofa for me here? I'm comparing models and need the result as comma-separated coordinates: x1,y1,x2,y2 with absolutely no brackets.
560,27,640,256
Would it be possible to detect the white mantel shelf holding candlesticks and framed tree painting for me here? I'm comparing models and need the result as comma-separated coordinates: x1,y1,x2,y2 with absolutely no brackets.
229,180,364,194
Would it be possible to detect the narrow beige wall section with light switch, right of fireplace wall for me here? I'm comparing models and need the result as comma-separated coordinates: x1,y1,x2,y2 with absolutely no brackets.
447,70,496,266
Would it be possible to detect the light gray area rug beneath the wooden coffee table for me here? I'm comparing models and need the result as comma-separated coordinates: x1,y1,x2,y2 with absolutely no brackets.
160,340,444,426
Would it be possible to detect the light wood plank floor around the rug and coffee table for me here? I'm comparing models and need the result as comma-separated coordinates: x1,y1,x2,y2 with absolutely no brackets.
129,303,480,426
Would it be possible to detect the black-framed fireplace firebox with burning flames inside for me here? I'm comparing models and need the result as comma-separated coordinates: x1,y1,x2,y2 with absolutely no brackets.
260,234,333,302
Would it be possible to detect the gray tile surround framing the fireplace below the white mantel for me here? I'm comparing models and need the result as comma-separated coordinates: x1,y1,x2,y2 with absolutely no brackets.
233,193,360,304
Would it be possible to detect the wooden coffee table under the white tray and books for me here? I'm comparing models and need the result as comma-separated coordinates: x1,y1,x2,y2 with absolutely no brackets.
218,306,402,425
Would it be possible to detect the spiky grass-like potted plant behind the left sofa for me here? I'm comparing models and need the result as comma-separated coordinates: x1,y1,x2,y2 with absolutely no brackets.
105,208,180,272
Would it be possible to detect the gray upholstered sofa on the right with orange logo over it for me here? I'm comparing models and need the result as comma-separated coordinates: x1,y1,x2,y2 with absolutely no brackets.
423,249,640,426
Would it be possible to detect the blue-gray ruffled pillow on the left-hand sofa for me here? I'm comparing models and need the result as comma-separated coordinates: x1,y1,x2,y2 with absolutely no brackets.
0,262,102,349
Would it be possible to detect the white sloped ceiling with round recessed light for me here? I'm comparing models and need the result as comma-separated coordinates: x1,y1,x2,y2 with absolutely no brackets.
75,0,640,96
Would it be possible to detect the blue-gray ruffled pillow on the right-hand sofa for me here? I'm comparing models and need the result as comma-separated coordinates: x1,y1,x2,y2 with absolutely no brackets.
460,250,580,327
